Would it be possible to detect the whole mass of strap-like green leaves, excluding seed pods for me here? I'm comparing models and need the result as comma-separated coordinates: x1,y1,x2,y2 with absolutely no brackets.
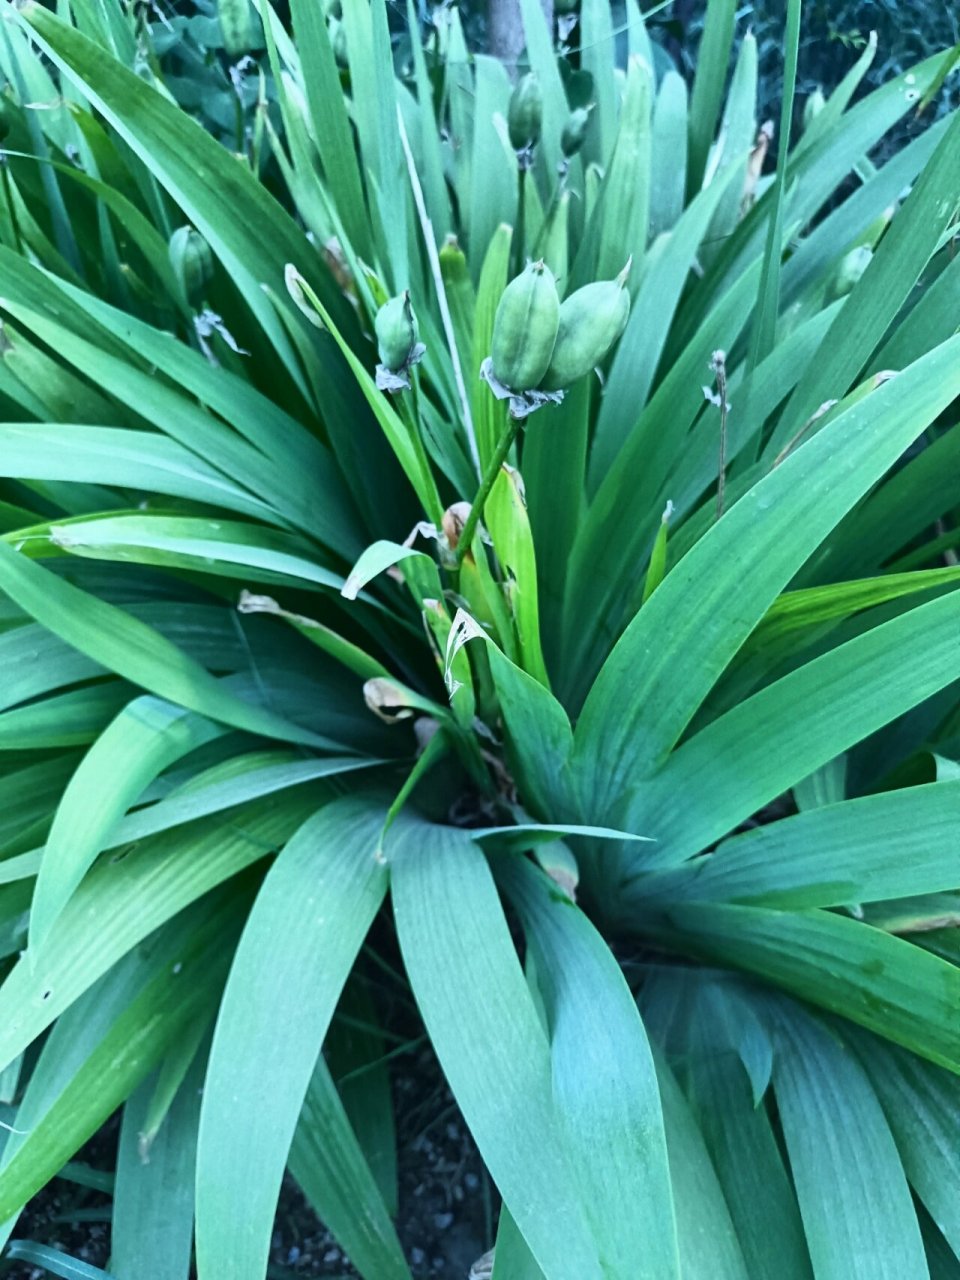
0,0,960,1280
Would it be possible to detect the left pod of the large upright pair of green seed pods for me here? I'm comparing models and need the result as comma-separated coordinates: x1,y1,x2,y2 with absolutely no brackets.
490,261,561,392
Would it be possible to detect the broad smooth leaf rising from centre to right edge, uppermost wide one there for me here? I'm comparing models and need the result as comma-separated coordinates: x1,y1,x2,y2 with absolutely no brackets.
575,339,960,813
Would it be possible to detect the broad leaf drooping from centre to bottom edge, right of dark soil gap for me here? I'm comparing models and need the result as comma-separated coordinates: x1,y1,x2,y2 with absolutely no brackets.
388,822,604,1280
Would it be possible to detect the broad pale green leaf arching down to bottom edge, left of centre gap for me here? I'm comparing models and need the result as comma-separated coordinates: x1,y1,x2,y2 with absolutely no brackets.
197,797,387,1280
